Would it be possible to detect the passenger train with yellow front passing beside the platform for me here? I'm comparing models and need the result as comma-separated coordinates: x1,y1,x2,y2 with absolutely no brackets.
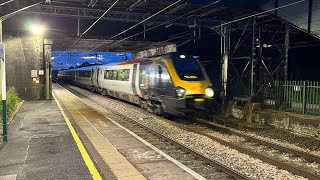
58,52,214,116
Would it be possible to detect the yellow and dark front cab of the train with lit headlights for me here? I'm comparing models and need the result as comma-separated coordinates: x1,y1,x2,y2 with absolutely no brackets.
139,53,214,116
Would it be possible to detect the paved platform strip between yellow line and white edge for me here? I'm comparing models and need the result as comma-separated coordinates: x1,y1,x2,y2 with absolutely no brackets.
53,84,201,180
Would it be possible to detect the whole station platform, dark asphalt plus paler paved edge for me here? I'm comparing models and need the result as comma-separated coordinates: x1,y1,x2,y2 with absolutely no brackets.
0,85,201,180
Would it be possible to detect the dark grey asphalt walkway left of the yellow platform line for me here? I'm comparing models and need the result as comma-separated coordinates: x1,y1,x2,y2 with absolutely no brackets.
0,101,91,180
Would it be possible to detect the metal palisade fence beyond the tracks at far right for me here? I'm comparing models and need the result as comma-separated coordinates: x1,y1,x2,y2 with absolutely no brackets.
261,81,320,114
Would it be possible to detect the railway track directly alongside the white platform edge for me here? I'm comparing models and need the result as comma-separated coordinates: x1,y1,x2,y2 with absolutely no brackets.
62,84,248,180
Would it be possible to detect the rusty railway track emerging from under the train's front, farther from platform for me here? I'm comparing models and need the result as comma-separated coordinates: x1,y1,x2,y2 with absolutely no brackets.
169,120,320,180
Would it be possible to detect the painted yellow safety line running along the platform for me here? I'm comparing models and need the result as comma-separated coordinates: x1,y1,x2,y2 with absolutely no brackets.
53,94,102,180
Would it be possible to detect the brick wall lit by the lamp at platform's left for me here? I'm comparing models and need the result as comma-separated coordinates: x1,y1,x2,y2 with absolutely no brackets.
3,36,44,100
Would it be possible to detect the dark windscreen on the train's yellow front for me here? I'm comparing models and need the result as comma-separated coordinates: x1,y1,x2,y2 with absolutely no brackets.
172,55,203,81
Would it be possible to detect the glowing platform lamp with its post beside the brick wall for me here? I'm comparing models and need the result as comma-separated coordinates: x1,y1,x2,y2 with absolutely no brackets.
27,24,51,100
